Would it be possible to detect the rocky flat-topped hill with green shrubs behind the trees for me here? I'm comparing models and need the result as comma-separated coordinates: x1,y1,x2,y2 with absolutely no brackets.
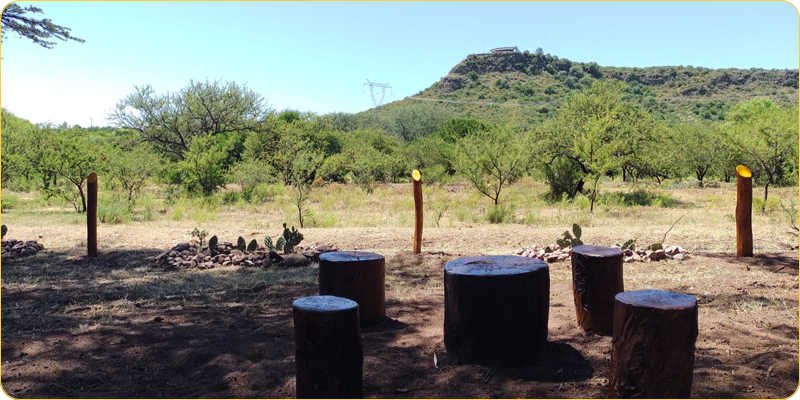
382,49,798,122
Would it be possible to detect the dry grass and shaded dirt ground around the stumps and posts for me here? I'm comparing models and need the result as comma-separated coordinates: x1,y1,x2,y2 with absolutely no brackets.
0,181,798,398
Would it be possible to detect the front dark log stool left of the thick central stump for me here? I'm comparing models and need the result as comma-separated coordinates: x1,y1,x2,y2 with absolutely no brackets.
293,296,364,399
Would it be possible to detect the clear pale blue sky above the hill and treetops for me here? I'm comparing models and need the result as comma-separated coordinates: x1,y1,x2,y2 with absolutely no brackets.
0,1,800,126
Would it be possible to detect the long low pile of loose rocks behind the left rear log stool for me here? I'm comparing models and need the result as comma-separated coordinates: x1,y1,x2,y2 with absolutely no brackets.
155,242,338,269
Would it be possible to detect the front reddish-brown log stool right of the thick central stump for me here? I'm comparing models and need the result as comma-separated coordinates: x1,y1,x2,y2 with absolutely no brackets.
608,290,697,399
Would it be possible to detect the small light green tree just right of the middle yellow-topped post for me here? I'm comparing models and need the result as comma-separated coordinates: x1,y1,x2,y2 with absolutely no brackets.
456,127,532,206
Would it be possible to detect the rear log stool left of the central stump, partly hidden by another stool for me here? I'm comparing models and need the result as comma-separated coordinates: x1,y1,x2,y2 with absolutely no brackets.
319,251,386,326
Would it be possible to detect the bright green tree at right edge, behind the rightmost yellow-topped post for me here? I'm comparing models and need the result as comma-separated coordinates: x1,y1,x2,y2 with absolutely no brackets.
726,98,798,204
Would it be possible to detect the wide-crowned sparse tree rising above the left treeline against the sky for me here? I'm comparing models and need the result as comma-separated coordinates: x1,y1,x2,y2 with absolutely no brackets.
108,81,269,161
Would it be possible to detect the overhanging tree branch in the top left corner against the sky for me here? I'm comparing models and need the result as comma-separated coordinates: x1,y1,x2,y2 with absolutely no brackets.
0,3,84,49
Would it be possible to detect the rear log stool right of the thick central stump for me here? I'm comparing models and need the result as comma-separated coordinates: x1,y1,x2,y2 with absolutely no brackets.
571,245,623,335
